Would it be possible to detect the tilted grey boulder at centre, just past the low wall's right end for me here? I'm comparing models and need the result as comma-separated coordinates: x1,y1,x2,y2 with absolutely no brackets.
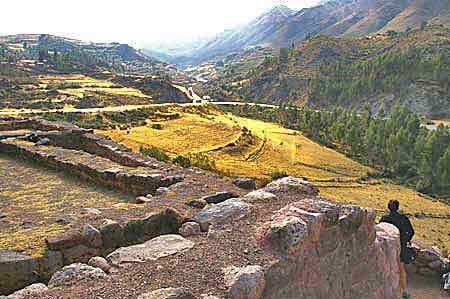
193,199,251,231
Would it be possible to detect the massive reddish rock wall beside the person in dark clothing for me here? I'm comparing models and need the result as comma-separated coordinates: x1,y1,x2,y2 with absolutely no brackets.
251,195,400,299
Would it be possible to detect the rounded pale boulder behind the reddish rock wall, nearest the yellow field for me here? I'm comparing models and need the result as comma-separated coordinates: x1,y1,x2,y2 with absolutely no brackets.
264,177,319,196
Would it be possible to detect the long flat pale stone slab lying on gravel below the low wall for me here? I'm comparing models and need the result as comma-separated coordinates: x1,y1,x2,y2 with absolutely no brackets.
106,235,194,266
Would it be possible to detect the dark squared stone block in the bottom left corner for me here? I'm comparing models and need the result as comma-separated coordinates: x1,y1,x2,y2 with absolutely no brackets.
0,250,40,294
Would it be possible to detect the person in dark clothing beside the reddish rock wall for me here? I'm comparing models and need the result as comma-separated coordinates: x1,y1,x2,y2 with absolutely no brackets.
380,200,414,298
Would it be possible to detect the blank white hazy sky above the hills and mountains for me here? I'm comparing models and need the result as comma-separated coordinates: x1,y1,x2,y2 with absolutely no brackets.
0,0,318,47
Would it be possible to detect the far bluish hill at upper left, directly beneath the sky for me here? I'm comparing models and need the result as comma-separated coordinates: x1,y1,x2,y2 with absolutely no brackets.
0,34,161,72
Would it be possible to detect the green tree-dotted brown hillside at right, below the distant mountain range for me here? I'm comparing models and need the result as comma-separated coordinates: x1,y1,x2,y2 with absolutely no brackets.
197,25,450,118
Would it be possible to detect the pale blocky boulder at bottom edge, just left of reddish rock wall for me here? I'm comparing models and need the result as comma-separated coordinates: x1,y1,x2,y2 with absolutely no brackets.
224,266,265,299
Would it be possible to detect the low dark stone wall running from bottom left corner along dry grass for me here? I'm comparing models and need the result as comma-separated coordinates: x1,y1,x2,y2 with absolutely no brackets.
0,208,185,294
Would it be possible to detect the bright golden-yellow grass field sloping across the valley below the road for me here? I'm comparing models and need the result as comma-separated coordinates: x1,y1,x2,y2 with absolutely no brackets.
99,108,450,249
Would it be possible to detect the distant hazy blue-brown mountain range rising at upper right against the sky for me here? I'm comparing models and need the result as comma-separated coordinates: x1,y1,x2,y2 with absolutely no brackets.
149,0,450,65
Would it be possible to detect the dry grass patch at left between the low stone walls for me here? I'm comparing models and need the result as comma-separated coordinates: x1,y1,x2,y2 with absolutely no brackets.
0,156,135,256
